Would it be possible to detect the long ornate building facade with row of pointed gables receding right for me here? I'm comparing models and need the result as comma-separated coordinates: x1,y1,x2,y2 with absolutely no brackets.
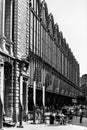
0,0,81,121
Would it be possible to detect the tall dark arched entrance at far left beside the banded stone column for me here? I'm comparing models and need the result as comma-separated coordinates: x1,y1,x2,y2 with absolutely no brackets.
4,62,13,116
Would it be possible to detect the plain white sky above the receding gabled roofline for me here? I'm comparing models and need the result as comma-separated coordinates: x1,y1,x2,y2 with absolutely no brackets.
45,0,87,76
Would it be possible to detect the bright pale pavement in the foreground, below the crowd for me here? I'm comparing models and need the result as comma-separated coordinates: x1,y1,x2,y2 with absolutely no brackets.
3,122,87,130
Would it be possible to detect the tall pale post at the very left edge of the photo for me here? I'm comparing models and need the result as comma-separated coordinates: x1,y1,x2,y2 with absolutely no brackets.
0,57,4,129
